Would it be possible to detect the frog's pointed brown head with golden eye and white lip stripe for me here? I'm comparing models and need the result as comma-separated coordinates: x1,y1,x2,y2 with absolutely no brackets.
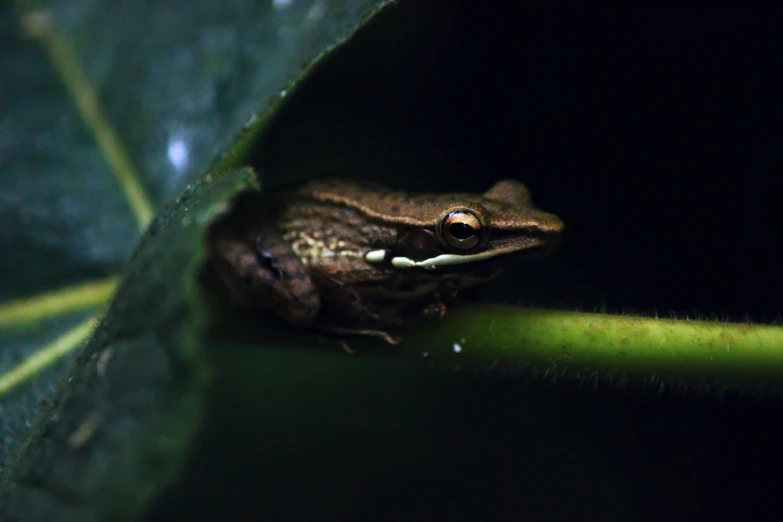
328,180,564,286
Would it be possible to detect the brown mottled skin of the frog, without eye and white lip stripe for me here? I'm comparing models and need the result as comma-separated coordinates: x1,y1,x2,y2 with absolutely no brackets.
211,178,563,343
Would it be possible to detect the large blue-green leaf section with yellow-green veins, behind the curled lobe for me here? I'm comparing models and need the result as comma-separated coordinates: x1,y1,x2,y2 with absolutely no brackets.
0,0,386,461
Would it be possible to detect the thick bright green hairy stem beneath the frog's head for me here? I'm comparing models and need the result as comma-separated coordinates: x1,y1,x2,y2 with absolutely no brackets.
401,306,783,386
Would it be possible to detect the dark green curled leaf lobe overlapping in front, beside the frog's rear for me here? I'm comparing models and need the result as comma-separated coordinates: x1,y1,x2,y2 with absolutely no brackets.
4,171,258,520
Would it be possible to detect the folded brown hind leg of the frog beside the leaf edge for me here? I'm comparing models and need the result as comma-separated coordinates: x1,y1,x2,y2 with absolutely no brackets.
213,227,321,326
